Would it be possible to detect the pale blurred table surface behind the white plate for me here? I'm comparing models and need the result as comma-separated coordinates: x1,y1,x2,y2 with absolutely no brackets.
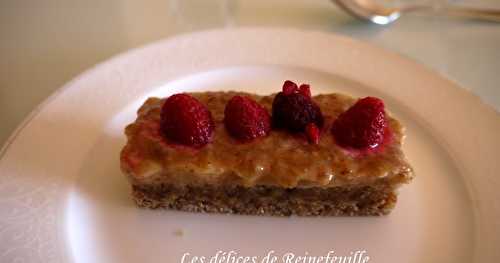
0,0,500,145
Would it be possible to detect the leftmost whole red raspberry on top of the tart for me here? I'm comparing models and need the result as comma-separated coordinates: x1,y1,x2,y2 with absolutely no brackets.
160,94,214,148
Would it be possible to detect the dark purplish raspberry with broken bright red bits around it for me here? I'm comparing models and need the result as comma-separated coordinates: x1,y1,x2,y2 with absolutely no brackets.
273,80,323,132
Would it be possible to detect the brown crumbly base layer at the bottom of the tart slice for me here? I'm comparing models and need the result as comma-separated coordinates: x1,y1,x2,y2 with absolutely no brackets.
133,184,397,216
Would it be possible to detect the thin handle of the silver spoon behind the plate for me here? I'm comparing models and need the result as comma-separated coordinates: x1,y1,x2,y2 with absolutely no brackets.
402,5,500,22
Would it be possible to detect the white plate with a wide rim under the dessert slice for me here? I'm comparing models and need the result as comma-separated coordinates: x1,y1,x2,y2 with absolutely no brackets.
0,29,500,263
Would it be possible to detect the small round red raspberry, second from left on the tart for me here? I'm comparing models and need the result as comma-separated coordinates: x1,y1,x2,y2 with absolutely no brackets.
224,96,271,141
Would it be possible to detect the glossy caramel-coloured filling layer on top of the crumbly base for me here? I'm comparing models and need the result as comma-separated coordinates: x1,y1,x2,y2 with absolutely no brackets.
121,92,413,188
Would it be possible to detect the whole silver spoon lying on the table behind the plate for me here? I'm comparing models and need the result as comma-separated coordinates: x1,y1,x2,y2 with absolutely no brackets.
332,0,500,25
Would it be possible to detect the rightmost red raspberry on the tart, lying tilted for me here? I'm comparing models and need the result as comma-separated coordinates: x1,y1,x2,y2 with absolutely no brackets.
332,97,386,149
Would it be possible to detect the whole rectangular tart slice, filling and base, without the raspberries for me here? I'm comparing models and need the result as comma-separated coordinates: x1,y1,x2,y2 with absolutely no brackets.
120,92,413,216
